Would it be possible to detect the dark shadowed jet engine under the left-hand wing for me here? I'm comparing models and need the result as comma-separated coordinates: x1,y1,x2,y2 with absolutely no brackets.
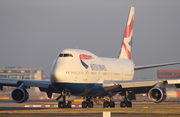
11,87,29,103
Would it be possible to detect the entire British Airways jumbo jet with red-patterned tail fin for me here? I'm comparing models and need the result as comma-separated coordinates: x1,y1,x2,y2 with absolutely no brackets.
0,7,180,108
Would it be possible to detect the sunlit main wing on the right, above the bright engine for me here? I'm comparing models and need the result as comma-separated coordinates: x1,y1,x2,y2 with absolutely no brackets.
103,79,180,95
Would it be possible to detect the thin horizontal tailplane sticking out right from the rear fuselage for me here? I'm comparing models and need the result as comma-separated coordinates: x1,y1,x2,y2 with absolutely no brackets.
134,62,180,70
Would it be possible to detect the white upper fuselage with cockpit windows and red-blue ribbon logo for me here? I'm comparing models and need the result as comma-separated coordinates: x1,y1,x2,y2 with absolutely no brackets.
51,49,135,95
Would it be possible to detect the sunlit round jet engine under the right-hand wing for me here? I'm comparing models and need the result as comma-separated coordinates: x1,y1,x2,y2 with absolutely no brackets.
148,87,167,103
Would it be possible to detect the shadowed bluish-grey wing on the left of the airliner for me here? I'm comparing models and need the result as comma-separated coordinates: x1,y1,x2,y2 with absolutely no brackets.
0,78,57,93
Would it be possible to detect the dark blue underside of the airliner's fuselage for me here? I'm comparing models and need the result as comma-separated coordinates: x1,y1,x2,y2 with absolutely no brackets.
52,83,107,96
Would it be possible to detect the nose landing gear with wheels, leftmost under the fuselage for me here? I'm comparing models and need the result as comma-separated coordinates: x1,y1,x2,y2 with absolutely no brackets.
56,91,71,108
